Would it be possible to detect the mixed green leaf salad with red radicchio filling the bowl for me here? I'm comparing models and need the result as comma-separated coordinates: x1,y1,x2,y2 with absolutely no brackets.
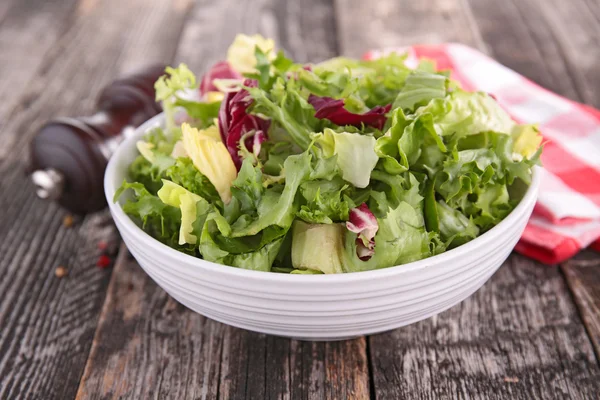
115,35,542,274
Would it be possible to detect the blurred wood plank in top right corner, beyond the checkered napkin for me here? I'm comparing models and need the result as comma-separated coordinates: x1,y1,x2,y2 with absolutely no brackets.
468,0,600,107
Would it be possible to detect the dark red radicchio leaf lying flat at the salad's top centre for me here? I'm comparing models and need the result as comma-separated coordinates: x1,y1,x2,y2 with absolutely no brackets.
308,94,392,129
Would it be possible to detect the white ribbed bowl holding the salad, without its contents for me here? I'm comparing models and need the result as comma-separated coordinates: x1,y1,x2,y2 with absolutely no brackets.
104,115,540,340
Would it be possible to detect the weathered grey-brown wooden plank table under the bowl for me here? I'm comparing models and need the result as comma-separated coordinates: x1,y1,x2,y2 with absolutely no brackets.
0,0,600,399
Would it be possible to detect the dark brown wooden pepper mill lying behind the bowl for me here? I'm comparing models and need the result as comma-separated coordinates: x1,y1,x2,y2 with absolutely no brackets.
27,65,165,214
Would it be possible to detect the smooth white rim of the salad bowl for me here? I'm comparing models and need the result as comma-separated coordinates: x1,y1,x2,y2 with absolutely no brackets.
104,113,541,283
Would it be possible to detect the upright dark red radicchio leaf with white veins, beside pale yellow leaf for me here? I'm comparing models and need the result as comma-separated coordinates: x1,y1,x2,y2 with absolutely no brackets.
219,79,271,171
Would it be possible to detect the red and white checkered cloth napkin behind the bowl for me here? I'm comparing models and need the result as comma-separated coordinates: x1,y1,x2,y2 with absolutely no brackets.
364,43,600,264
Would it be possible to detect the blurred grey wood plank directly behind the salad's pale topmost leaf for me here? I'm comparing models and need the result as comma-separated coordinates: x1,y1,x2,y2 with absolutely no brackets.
176,0,337,73
